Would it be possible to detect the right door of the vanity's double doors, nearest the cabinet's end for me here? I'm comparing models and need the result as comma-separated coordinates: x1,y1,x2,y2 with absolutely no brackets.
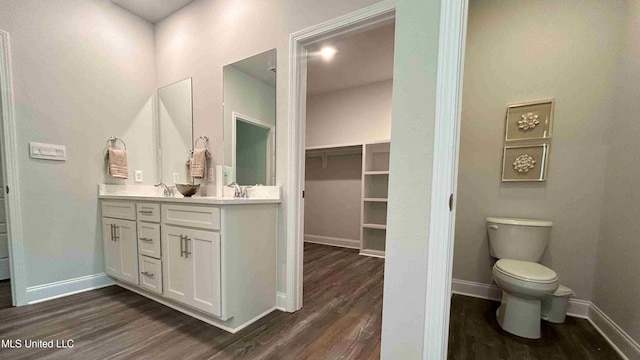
185,230,222,316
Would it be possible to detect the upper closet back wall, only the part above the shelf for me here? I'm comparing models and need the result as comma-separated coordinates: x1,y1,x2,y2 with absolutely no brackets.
306,80,393,147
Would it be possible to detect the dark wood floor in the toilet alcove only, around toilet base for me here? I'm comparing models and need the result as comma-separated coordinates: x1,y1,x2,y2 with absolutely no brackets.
449,295,621,360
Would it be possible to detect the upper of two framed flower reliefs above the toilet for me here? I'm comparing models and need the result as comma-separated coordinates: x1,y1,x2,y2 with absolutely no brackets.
504,99,555,142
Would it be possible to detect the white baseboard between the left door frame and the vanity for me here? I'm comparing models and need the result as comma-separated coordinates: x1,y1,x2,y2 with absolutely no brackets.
27,273,115,304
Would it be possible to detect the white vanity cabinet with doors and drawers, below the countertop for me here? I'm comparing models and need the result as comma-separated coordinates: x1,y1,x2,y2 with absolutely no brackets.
101,196,279,332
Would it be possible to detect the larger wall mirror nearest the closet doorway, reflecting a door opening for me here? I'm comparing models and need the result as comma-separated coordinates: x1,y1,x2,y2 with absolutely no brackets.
223,49,276,185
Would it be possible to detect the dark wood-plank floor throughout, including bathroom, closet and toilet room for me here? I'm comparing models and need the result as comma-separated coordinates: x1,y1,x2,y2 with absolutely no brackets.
0,244,619,360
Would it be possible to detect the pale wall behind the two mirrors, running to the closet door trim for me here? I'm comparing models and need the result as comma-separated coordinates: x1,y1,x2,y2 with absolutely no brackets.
155,0,384,291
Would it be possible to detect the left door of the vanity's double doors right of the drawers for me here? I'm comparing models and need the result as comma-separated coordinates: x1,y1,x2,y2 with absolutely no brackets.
162,225,192,304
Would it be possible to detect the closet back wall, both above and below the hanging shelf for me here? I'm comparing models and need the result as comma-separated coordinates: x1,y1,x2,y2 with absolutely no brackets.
304,80,393,245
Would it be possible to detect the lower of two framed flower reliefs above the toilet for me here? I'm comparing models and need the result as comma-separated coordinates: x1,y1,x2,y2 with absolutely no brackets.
502,144,550,181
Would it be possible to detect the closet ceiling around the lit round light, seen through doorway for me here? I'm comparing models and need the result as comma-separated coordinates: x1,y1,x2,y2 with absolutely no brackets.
307,23,395,95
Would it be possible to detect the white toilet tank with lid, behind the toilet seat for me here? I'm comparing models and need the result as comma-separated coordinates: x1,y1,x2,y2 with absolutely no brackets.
487,217,553,262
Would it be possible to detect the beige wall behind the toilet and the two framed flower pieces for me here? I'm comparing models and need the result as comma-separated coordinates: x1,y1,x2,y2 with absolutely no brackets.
453,0,624,300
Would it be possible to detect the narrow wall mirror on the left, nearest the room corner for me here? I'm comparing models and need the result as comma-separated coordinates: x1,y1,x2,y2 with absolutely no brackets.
158,78,193,184
